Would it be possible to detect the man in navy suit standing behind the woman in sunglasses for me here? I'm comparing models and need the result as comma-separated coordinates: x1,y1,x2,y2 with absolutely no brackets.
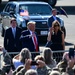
48,9,61,28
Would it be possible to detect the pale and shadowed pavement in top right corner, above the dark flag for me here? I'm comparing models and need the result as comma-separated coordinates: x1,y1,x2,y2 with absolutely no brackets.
55,0,75,15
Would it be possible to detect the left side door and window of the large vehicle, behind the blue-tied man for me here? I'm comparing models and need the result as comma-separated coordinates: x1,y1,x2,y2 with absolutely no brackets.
2,4,15,30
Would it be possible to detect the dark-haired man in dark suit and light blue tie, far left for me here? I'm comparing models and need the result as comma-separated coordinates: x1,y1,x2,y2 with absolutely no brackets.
4,18,21,52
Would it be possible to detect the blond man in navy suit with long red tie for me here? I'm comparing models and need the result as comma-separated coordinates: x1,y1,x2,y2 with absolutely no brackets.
20,21,39,58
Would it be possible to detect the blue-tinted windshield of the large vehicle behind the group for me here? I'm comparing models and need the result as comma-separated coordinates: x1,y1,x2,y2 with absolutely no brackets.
19,4,52,15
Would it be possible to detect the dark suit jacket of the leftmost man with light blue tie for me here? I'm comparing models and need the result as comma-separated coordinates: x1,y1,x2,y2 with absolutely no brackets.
4,27,22,52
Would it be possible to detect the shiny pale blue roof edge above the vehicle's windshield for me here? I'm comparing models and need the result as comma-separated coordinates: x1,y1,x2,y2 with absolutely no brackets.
8,1,48,5
